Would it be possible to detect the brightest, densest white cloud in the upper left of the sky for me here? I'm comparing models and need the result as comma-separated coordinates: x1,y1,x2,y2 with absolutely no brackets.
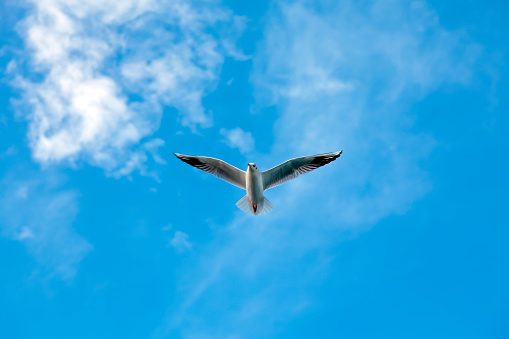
10,0,243,176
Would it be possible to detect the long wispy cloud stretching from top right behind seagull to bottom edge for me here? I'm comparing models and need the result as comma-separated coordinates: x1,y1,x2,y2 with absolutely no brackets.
157,1,480,338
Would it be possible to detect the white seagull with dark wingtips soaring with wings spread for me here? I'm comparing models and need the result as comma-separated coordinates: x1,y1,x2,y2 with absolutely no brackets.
173,151,343,215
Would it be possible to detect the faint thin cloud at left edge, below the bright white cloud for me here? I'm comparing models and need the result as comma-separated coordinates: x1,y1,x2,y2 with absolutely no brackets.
0,175,92,281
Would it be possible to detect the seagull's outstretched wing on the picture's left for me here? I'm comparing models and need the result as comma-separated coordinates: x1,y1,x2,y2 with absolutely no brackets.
173,153,246,189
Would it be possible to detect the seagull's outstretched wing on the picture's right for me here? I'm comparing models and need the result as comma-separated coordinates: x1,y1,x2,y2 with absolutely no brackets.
262,151,343,190
